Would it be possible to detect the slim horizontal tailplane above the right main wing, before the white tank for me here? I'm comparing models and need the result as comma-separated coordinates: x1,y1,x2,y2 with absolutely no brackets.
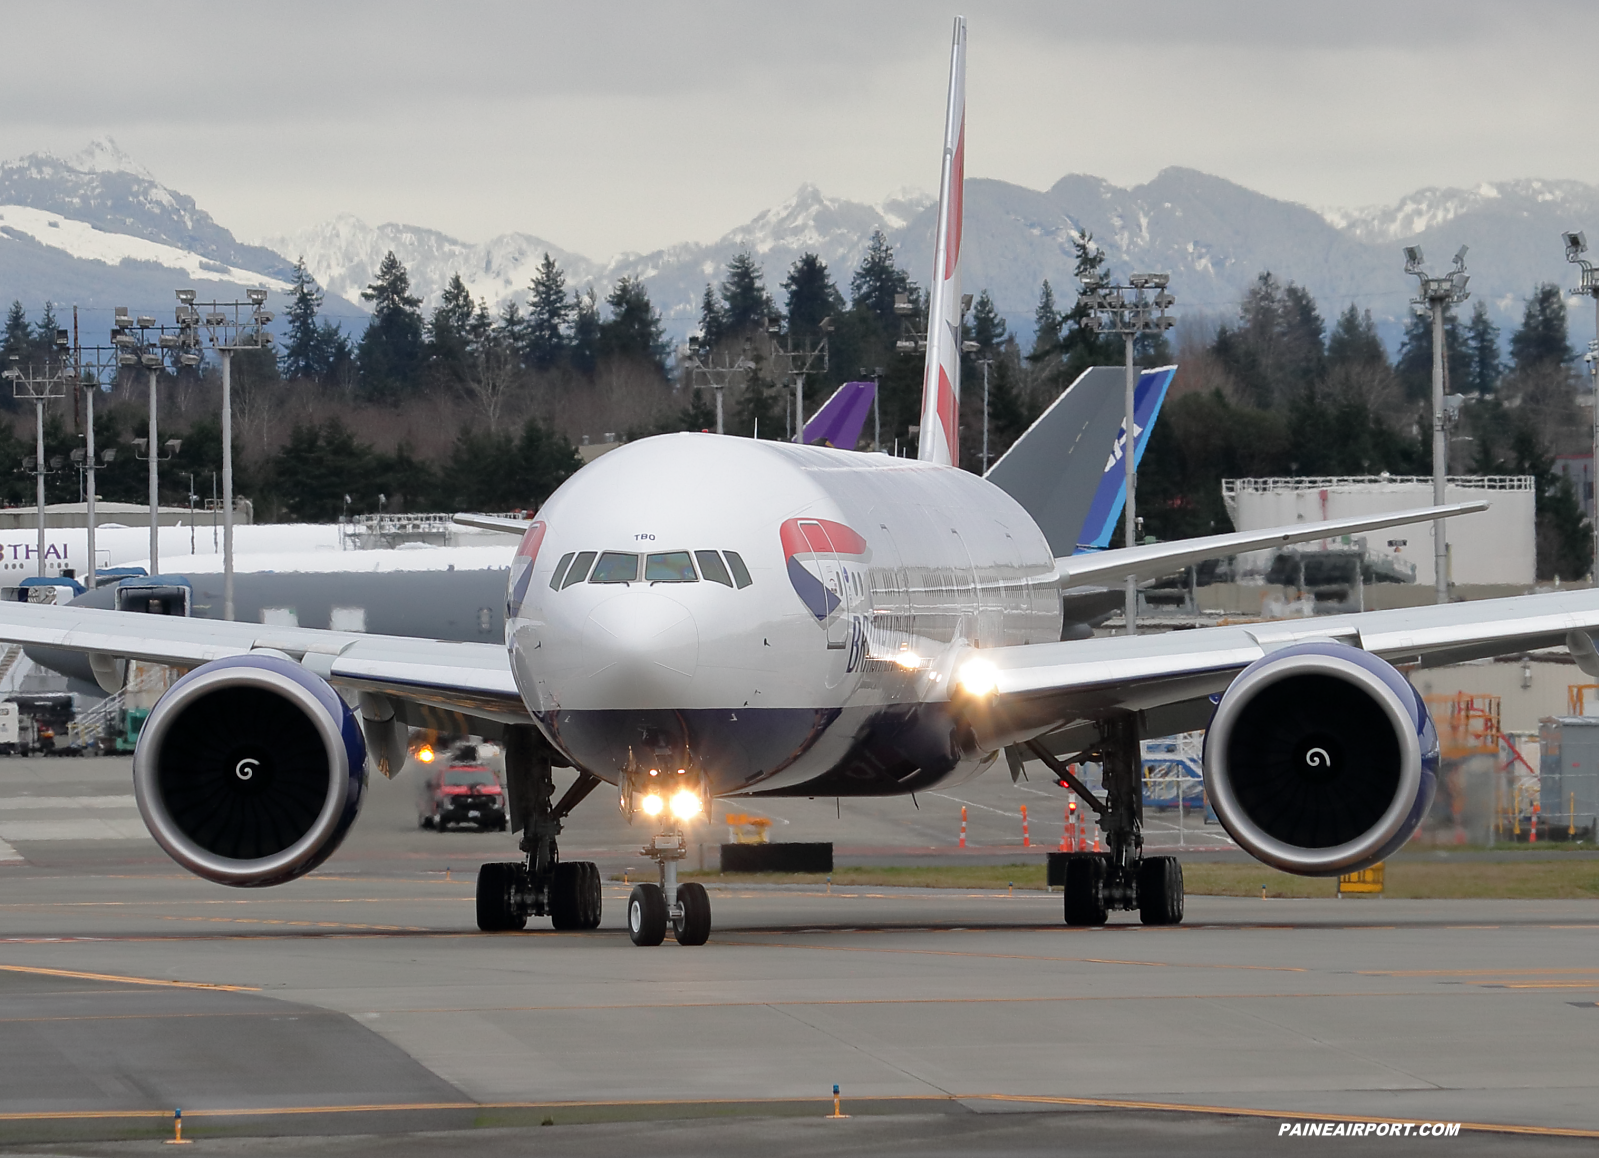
1055,499,1489,587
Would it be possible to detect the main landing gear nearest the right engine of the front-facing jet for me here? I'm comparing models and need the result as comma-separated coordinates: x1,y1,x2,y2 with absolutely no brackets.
1028,717,1183,926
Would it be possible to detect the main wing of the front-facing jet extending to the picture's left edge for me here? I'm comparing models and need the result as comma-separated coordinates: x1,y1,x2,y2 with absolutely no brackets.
0,603,528,723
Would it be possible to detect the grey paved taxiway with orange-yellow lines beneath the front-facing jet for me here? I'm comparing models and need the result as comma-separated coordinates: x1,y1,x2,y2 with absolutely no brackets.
0,760,1599,1155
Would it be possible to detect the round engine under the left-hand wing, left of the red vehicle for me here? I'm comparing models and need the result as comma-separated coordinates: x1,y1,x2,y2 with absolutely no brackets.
133,654,366,886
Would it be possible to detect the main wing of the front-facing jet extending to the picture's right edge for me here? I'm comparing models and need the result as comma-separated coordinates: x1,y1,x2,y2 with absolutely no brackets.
956,590,1599,742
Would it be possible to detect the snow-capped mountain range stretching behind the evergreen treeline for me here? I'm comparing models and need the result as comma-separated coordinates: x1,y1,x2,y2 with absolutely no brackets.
0,139,1599,350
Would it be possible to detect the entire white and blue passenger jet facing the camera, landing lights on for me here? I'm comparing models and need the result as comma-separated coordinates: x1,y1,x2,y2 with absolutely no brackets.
0,19,1579,945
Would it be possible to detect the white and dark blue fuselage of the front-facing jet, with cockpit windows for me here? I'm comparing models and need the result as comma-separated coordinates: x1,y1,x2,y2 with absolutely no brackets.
505,433,1062,795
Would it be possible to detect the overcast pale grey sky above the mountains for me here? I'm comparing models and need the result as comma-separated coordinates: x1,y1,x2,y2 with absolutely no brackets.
0,0,1599,258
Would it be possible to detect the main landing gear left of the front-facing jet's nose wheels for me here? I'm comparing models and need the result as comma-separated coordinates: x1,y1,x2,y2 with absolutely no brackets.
478,726,600,932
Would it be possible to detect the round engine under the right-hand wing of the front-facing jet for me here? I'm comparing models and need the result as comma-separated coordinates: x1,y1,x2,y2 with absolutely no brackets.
1204,643,1438,876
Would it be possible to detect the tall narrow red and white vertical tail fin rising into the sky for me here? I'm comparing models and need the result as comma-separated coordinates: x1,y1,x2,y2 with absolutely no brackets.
916,16,966,467
